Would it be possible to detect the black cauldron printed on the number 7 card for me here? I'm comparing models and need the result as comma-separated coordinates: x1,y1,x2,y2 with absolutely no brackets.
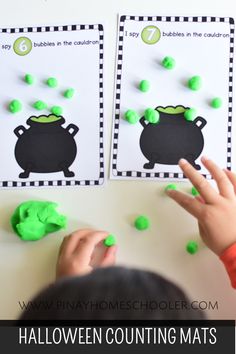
140,106,207,170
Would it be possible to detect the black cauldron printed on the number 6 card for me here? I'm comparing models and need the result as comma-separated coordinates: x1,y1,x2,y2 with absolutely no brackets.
14,115,79,178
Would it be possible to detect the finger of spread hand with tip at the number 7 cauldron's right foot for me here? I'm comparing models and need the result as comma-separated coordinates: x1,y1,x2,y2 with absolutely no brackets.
201,156,234,198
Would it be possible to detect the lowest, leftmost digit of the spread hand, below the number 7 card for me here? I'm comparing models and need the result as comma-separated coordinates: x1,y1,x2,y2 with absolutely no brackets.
166,190,204,219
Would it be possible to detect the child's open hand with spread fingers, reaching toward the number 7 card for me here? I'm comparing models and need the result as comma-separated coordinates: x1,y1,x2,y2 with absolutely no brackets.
167,157,236,255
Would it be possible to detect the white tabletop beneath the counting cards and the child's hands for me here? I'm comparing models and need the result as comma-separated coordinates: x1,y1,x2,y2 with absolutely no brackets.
0,0,236,319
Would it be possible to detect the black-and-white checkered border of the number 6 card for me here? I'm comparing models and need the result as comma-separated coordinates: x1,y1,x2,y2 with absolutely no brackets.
0,24,104,188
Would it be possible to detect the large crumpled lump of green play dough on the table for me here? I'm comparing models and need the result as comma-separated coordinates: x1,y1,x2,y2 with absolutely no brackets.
10,201,67,241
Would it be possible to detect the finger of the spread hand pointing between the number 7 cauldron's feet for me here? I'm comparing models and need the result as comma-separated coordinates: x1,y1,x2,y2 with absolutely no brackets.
179,159,219,204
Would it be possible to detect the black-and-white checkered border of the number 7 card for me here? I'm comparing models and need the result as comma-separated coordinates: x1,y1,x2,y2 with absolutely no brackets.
111,15,235,179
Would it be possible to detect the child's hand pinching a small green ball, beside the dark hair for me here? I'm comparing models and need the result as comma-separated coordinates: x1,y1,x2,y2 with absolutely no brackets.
56,229,117,279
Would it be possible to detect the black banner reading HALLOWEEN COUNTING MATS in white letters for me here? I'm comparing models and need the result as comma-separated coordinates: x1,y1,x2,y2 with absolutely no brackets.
0,320,235,354
